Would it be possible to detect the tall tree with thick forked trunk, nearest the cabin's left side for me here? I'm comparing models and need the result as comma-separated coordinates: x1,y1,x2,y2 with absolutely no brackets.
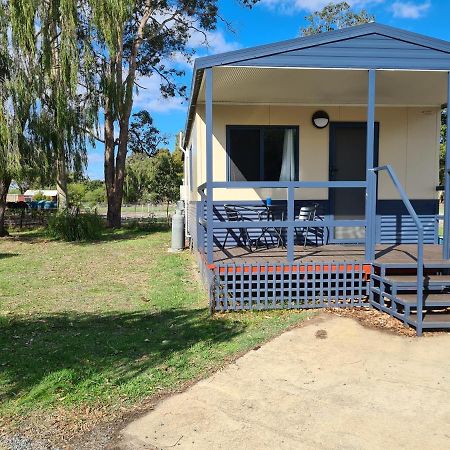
79,0,258,227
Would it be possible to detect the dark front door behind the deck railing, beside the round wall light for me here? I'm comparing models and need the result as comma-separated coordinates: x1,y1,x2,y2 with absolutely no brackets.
330,122,379,242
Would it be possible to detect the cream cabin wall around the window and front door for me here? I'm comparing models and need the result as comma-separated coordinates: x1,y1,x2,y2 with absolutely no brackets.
191,105,440,200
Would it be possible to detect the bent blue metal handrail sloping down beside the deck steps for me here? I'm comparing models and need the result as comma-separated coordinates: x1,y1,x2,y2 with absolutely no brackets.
369,164,423,336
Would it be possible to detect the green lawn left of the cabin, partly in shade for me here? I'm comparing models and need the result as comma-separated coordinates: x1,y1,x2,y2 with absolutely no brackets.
0,229,306,440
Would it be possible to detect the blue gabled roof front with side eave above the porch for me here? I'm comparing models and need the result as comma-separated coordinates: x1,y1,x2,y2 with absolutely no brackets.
185,23,450,141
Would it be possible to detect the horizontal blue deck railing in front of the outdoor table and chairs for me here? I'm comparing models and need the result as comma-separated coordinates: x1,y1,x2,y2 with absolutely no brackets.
198,180,367,263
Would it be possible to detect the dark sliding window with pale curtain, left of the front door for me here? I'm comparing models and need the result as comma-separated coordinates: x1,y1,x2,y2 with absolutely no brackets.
227,125,299,181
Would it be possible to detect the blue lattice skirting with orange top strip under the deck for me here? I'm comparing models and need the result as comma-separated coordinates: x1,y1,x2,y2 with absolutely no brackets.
210,261,371,312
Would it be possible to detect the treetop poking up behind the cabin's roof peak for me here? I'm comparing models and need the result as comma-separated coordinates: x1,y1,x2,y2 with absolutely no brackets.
300,2,375,36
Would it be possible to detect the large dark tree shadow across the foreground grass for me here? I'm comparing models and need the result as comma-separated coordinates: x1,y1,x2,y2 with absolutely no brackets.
0,309,246,407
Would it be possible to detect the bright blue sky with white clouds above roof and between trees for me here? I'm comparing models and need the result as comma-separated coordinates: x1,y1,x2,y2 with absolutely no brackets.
87,0,450,179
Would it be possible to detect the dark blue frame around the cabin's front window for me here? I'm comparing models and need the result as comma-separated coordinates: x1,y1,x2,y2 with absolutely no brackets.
226,125,300,183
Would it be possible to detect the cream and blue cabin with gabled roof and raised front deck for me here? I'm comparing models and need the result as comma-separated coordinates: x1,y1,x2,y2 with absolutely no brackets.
184,23,450,335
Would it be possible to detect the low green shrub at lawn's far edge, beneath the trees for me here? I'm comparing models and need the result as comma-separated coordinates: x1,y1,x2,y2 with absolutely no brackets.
47,210,104,242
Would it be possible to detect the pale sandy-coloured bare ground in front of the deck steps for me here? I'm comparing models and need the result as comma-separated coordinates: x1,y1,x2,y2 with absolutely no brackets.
119,315,450,450
